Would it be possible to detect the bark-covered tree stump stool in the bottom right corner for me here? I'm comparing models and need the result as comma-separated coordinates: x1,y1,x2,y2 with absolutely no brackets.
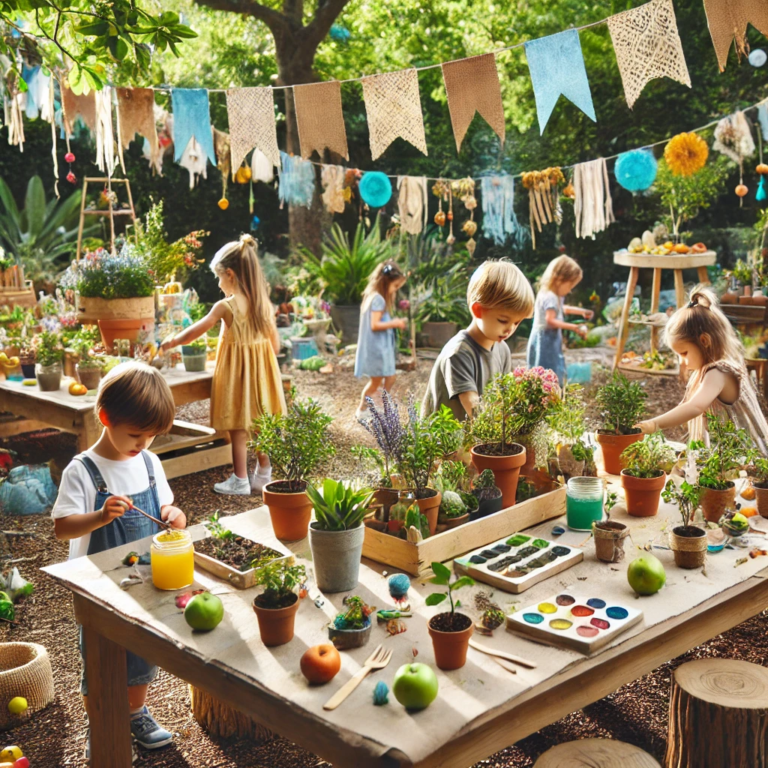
664,659,768,768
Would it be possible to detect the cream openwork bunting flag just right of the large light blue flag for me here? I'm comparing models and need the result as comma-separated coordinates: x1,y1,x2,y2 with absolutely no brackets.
608,0,692,109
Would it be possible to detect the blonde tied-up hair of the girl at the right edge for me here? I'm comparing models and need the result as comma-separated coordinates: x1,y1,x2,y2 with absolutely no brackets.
664,285,744,367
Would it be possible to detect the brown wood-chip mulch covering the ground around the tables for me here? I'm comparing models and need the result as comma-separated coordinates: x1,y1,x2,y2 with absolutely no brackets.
0,361,768,768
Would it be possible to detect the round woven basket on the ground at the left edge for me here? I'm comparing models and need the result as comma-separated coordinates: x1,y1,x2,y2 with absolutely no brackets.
0,643,54,730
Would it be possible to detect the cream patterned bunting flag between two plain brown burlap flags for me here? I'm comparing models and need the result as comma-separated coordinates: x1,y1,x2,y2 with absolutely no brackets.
362,69,427,160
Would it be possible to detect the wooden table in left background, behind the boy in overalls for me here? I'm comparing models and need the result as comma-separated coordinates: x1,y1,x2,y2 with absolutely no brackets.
0,368,232,479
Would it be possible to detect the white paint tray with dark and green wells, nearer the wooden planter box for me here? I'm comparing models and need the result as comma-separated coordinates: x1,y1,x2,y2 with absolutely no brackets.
453,533,584,594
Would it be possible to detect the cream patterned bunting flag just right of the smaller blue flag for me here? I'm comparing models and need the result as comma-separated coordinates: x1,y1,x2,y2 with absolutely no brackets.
227,88,280,178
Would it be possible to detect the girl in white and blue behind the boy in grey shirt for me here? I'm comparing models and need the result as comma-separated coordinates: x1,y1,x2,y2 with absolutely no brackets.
528,256,594,387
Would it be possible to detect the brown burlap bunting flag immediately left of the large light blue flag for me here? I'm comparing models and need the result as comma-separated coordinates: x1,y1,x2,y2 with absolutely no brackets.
443,53,505,152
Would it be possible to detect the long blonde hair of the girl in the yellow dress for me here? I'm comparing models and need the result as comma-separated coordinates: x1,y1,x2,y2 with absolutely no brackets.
211,235,275,336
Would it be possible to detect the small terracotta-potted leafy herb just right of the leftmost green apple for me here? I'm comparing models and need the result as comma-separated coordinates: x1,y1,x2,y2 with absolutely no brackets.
253,560,307,647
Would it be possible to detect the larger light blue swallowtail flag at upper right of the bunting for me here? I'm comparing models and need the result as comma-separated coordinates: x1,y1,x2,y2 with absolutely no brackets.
525,29,597,133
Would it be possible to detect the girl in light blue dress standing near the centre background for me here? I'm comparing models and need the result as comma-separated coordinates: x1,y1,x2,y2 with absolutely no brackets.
355,260,408,421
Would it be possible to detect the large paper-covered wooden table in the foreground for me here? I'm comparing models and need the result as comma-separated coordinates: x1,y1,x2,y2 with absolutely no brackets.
44,486,768,768
